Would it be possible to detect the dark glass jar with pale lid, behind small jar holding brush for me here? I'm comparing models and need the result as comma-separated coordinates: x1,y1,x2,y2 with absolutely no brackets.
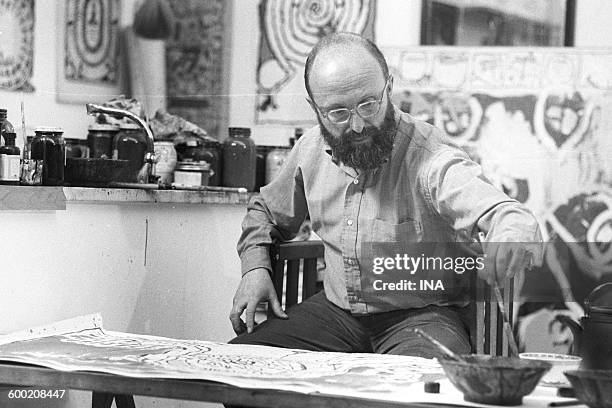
30,126,66,186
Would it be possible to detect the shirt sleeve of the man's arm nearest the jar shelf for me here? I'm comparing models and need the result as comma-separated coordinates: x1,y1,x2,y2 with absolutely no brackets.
237,144,308,275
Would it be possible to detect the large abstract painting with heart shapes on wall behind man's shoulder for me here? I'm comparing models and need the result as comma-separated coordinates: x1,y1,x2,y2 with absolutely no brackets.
383,47,612,352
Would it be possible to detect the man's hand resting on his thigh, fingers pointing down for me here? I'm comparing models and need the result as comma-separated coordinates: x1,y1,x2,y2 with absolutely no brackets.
230,268,288,334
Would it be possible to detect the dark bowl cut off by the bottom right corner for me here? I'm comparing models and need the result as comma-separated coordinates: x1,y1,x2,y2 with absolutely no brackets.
564,370,612,408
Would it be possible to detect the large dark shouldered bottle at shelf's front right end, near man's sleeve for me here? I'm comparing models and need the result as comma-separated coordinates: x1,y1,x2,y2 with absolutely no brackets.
223,127,257,191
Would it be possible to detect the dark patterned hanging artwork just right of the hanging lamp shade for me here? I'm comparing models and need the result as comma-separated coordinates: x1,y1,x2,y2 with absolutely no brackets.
166,0,231,137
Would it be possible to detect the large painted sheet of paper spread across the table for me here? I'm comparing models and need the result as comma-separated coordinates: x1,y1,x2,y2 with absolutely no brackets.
0,315,572,407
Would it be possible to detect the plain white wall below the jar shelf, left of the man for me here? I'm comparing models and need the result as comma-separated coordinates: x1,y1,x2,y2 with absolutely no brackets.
0,202,246,408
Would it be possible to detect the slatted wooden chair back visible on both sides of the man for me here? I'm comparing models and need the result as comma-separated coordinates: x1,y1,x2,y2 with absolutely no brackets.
268,241,514,356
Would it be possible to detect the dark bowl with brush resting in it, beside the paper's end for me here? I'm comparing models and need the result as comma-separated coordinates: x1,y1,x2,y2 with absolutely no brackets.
439,354,551,405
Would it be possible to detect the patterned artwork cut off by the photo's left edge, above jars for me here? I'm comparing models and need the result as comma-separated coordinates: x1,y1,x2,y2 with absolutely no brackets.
0,0,35,92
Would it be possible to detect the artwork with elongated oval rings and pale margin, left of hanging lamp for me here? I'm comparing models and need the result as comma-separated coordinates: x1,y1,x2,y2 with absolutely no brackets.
57,0,122,103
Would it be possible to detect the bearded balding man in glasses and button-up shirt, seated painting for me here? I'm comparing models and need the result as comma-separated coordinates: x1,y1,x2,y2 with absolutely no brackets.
230,33,541,358
